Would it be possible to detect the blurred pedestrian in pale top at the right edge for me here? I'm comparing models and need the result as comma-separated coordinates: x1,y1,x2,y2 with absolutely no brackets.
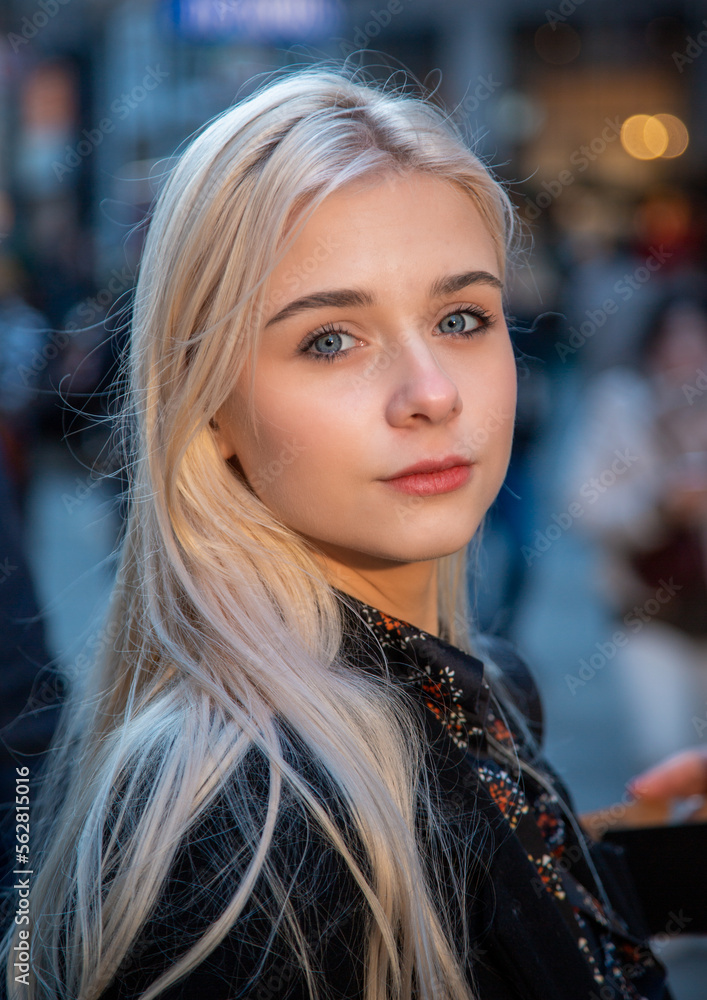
568,291,707,765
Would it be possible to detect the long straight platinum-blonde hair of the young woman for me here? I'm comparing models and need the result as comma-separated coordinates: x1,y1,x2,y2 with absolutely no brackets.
5,67,513,1000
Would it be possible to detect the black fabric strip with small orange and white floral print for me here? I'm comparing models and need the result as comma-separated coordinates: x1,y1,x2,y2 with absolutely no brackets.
347,597,656,1000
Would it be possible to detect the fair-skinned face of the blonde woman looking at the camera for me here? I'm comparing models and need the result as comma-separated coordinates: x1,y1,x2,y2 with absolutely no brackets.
217,174,516,566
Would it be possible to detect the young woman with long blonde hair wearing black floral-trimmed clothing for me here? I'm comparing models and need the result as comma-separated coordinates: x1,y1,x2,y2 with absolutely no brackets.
1,69,667,1000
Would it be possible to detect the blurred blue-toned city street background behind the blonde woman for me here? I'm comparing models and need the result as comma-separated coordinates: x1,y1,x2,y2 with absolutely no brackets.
0,0,707,1000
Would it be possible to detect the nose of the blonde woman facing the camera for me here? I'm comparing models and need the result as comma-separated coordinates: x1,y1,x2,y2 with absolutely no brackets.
386,338,462,427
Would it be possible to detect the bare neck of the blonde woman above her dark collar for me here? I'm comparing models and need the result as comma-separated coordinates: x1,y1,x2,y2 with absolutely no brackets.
314,549,439,635
